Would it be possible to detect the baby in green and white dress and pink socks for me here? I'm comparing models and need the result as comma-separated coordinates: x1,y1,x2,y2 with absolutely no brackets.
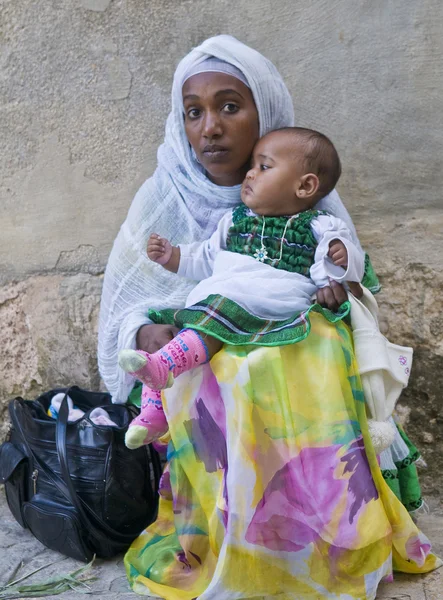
119,127,364,448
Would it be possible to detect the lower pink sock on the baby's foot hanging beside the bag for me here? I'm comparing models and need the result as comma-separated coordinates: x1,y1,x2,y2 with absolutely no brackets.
125,385,168,450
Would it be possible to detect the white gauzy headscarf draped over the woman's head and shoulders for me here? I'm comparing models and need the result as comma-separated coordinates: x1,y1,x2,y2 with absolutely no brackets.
98,35,362,402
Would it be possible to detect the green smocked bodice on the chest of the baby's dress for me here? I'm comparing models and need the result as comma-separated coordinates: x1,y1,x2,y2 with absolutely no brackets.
226,204,327,277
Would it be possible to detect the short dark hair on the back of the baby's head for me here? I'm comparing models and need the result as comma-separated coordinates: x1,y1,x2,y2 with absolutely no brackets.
276,127,341,198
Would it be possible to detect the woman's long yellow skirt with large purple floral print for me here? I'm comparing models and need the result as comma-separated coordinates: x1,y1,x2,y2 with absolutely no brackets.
125,313,441,600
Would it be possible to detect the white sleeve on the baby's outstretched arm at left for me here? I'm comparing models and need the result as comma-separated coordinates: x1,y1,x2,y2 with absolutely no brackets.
177,211,232,281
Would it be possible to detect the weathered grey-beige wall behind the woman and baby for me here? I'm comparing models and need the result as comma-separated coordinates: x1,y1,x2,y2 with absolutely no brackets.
0,0,443,492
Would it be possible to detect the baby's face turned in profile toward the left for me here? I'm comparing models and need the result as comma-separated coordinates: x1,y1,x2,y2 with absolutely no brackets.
241,131,310,216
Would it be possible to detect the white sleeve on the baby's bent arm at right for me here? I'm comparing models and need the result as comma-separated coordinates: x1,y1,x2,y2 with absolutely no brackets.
310,215,365,288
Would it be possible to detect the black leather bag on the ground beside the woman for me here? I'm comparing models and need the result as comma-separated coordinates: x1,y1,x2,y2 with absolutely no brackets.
0,386,161,562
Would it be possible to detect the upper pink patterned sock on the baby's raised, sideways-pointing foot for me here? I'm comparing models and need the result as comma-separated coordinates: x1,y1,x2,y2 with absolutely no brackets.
119,329,209,390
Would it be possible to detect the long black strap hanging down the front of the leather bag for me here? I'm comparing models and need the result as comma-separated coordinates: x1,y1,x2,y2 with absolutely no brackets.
55,389,160,543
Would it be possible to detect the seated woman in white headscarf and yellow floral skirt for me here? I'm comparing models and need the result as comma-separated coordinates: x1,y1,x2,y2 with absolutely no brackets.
99,36,439,600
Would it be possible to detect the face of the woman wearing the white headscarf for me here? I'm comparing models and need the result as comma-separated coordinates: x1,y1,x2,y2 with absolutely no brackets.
183,73,259,186
